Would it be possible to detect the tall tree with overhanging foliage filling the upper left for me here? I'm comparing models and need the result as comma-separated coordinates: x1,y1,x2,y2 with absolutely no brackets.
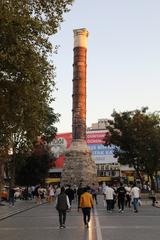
0,0,73,189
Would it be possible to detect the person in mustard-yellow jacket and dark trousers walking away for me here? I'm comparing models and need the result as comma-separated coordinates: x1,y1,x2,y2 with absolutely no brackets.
80,187,93,228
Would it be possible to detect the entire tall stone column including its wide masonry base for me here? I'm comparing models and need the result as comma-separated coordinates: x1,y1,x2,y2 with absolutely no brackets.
61,28,96,186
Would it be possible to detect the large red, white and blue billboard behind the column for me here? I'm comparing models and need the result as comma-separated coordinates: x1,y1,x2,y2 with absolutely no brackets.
50,130,117,168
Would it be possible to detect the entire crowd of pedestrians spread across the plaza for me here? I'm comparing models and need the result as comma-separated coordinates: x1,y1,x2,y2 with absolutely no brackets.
4,182,155,228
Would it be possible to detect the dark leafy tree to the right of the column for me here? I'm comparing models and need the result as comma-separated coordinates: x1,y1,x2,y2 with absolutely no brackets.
105,108,160,188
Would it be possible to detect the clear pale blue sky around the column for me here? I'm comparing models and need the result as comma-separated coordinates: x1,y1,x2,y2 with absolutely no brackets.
53,0,160,133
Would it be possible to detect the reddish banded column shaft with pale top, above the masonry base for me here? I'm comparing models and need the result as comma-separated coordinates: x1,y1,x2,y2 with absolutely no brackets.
72,28,88,141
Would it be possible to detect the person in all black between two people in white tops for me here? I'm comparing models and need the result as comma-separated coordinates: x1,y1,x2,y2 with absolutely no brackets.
117,182,126,213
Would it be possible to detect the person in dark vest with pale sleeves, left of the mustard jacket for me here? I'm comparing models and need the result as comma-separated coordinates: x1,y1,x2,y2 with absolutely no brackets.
56,187,70,228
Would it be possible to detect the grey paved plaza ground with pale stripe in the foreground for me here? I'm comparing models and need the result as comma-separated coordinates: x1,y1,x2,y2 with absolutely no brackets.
0,196,160,240
